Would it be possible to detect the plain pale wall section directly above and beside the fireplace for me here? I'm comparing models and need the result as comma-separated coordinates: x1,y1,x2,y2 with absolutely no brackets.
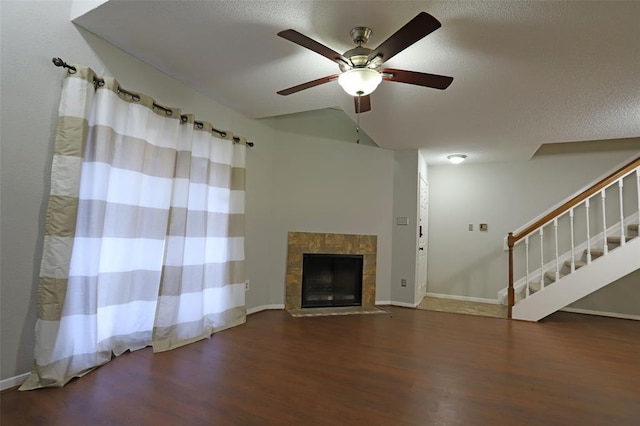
269,131,393,303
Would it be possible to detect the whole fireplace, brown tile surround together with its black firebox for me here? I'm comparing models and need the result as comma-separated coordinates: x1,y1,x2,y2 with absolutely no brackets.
285,232,377,312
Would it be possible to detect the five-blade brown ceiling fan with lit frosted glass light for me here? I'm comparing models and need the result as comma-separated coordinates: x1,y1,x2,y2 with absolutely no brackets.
277,12,453,114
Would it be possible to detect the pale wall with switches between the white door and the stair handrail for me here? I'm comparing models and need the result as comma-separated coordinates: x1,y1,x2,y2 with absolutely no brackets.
427,151,640,308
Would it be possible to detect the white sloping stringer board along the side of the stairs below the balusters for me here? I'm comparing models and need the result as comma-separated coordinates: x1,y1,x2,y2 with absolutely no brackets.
512,238,640,321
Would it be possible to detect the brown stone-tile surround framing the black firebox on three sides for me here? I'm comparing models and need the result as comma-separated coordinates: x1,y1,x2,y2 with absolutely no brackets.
285,232,378,310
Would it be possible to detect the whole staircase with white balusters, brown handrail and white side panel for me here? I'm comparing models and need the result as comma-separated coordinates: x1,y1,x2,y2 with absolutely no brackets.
502,158,640,321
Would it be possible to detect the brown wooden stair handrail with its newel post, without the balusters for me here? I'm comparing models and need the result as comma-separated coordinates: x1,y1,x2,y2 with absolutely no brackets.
507,157,640,319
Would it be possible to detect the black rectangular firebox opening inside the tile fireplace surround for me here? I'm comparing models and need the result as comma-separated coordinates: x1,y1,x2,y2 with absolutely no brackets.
301,253,363,308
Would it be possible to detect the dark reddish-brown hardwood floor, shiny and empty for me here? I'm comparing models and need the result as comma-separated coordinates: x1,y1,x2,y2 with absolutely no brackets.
0,307,640,426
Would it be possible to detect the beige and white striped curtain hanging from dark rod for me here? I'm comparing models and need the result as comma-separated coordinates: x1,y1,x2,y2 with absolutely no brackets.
20,66,246,390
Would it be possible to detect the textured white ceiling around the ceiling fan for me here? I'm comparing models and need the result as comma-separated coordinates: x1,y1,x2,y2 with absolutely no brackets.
74,0,640,164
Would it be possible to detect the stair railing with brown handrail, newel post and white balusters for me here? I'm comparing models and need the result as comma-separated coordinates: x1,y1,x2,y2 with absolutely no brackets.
507,157,640,318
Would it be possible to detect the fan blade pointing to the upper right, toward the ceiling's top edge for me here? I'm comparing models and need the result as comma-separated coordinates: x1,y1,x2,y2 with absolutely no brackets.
368,12,442,63
